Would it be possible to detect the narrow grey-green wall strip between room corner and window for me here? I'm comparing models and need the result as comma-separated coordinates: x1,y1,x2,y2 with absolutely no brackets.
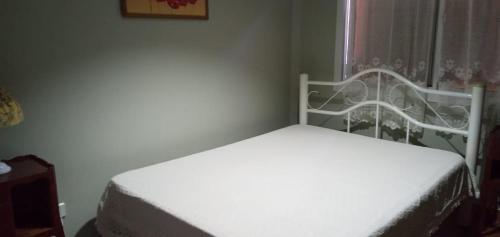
290,0,337,123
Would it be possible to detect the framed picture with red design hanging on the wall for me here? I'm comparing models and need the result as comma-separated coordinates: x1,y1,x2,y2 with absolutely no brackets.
121,0,208,20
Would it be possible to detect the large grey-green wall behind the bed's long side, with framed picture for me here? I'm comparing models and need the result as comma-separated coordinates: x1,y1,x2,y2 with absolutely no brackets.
0,0,291,236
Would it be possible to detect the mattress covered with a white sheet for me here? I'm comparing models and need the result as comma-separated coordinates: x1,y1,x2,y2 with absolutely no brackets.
96,125,472,237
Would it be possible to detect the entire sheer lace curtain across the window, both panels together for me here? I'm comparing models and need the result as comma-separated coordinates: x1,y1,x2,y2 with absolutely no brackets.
344,0,500,91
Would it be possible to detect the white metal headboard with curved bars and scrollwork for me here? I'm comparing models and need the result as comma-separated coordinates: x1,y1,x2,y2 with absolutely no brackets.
299,68,484,187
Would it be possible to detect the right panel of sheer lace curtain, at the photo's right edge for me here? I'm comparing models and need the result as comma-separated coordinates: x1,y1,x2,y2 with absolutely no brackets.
435,0,500,92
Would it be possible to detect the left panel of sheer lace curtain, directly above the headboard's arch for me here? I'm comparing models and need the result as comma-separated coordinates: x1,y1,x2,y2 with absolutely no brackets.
344,0,436,85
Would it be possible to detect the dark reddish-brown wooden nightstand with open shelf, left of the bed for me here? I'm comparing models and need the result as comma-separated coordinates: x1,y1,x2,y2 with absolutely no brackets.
0,155,64,237
